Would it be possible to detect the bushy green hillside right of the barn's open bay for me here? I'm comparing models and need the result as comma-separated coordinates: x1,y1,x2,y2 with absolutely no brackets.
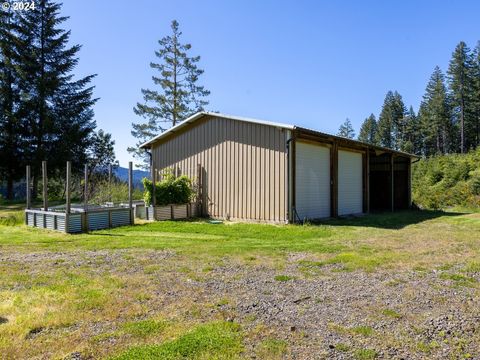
412,148,480,209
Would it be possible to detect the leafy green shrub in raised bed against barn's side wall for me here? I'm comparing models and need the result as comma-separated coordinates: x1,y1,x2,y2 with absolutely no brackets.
143,170,195,205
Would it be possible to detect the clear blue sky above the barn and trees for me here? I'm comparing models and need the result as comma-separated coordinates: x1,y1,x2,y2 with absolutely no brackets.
62,0,480,166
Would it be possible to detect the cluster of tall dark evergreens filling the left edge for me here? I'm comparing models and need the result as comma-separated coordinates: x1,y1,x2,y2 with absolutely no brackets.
0,0,115,199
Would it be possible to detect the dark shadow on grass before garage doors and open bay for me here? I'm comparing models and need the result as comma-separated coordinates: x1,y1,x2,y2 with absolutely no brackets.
318,210,466,229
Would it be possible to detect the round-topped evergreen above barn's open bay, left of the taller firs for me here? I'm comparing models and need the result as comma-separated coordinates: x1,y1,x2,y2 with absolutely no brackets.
376,91,406,149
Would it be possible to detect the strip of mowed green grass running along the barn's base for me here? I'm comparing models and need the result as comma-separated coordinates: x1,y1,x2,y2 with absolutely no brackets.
0,205,480,271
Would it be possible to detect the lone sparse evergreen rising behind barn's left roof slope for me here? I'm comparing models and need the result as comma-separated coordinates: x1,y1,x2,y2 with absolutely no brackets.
127,20,210,168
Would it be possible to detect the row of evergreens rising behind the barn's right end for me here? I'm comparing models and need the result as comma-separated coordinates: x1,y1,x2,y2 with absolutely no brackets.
339,41,480,156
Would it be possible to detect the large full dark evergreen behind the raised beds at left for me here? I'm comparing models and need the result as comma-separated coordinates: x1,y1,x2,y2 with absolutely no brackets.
16,0,96,196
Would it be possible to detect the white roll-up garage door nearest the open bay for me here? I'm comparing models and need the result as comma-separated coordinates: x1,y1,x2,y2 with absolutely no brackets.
338,150,363,215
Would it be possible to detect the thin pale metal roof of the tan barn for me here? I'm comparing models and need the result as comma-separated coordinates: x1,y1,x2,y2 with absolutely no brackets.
140,111,419,158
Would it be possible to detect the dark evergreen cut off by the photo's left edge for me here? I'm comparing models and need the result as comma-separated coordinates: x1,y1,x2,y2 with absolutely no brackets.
0,2,23,199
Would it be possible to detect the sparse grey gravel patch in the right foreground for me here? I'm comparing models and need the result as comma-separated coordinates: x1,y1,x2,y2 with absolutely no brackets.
204,256,480,359
